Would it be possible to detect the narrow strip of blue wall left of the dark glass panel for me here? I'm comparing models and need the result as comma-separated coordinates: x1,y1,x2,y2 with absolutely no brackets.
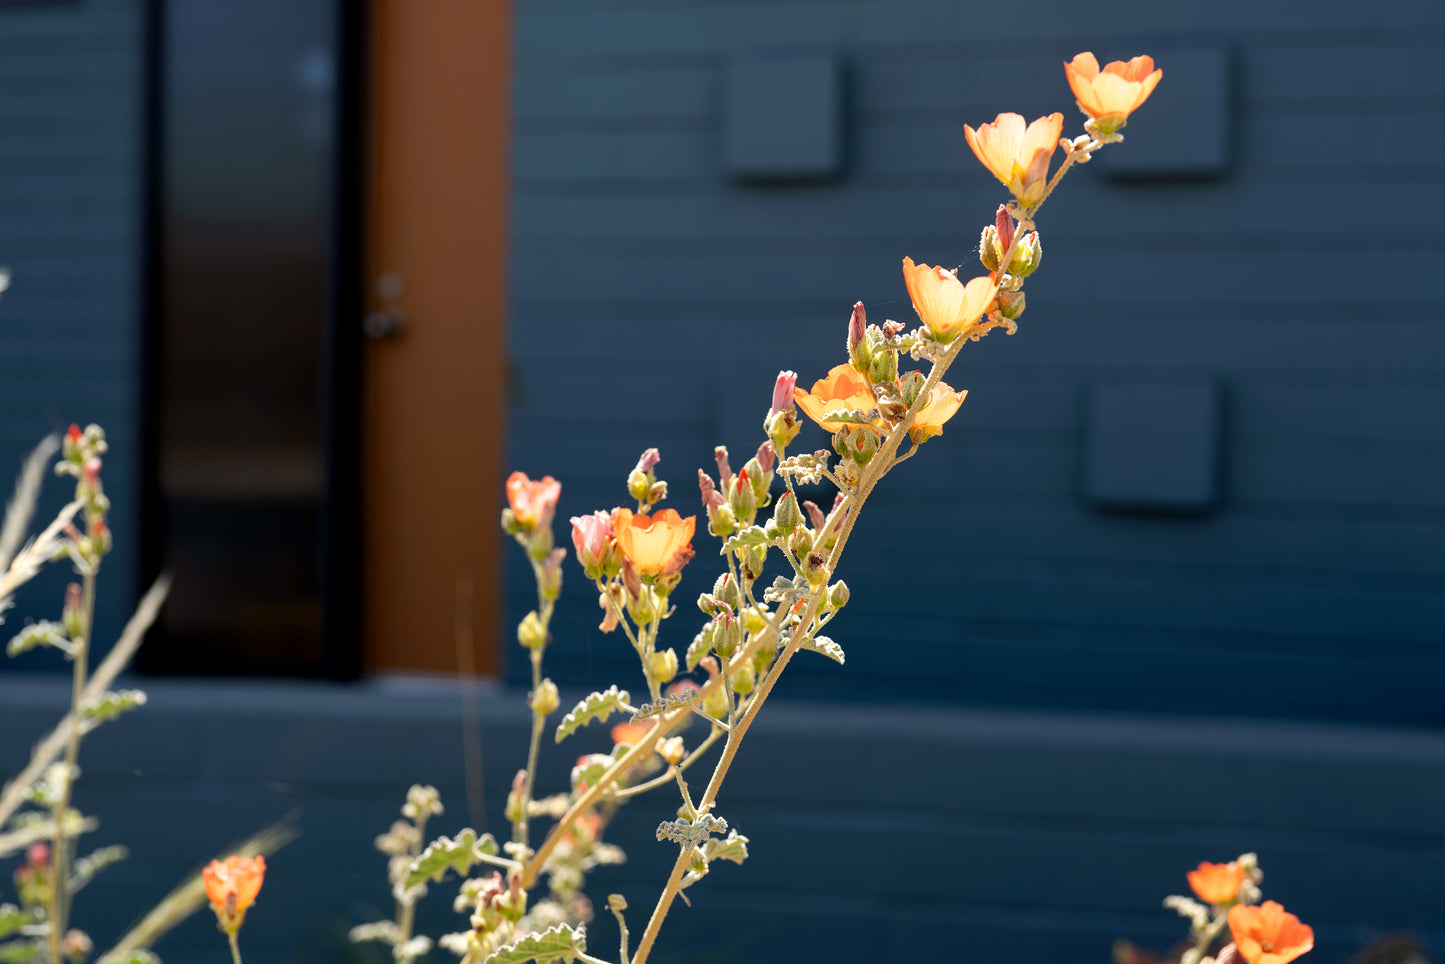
0,0,145,656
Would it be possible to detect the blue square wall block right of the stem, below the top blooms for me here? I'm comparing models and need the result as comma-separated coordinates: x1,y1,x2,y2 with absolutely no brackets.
1084,380,1222,513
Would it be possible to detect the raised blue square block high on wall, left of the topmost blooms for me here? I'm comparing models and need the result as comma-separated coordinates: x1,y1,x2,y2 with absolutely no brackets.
725,53,844,181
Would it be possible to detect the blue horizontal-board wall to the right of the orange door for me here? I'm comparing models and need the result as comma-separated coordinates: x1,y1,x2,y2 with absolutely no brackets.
507,0,1445,724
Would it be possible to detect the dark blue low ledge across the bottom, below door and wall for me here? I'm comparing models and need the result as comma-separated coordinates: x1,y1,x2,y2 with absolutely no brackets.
0,676,1445,963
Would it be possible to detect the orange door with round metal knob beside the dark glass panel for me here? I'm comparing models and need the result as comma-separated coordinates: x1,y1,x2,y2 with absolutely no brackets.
361,0,510,675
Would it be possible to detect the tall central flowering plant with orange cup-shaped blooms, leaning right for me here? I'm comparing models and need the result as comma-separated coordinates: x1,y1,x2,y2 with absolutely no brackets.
338,53,1312,964
